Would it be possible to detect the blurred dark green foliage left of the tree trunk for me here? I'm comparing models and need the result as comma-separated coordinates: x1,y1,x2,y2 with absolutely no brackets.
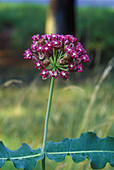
0,3,47,48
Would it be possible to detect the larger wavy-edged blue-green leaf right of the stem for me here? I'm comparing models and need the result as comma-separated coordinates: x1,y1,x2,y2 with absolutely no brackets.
46,132,114,169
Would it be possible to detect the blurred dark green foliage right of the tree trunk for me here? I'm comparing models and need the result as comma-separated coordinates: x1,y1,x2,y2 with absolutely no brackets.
77,8,114,63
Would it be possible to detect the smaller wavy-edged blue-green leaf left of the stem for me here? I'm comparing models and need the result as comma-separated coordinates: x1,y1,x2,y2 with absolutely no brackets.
0,142,44,170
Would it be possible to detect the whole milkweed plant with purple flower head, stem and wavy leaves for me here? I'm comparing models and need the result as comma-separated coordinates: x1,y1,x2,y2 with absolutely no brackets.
0,33,114,170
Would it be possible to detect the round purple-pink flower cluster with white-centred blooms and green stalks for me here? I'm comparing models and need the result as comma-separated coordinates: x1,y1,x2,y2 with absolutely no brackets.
24,33,90,79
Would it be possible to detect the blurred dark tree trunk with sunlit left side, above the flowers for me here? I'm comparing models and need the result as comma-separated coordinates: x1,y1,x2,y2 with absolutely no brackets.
45,0,75,35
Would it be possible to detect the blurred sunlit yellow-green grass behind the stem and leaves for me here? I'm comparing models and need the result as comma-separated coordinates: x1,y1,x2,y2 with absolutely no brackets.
0,67,114,170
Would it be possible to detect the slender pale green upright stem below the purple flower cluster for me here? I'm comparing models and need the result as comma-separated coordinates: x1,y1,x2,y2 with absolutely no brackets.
42,77,54,170
